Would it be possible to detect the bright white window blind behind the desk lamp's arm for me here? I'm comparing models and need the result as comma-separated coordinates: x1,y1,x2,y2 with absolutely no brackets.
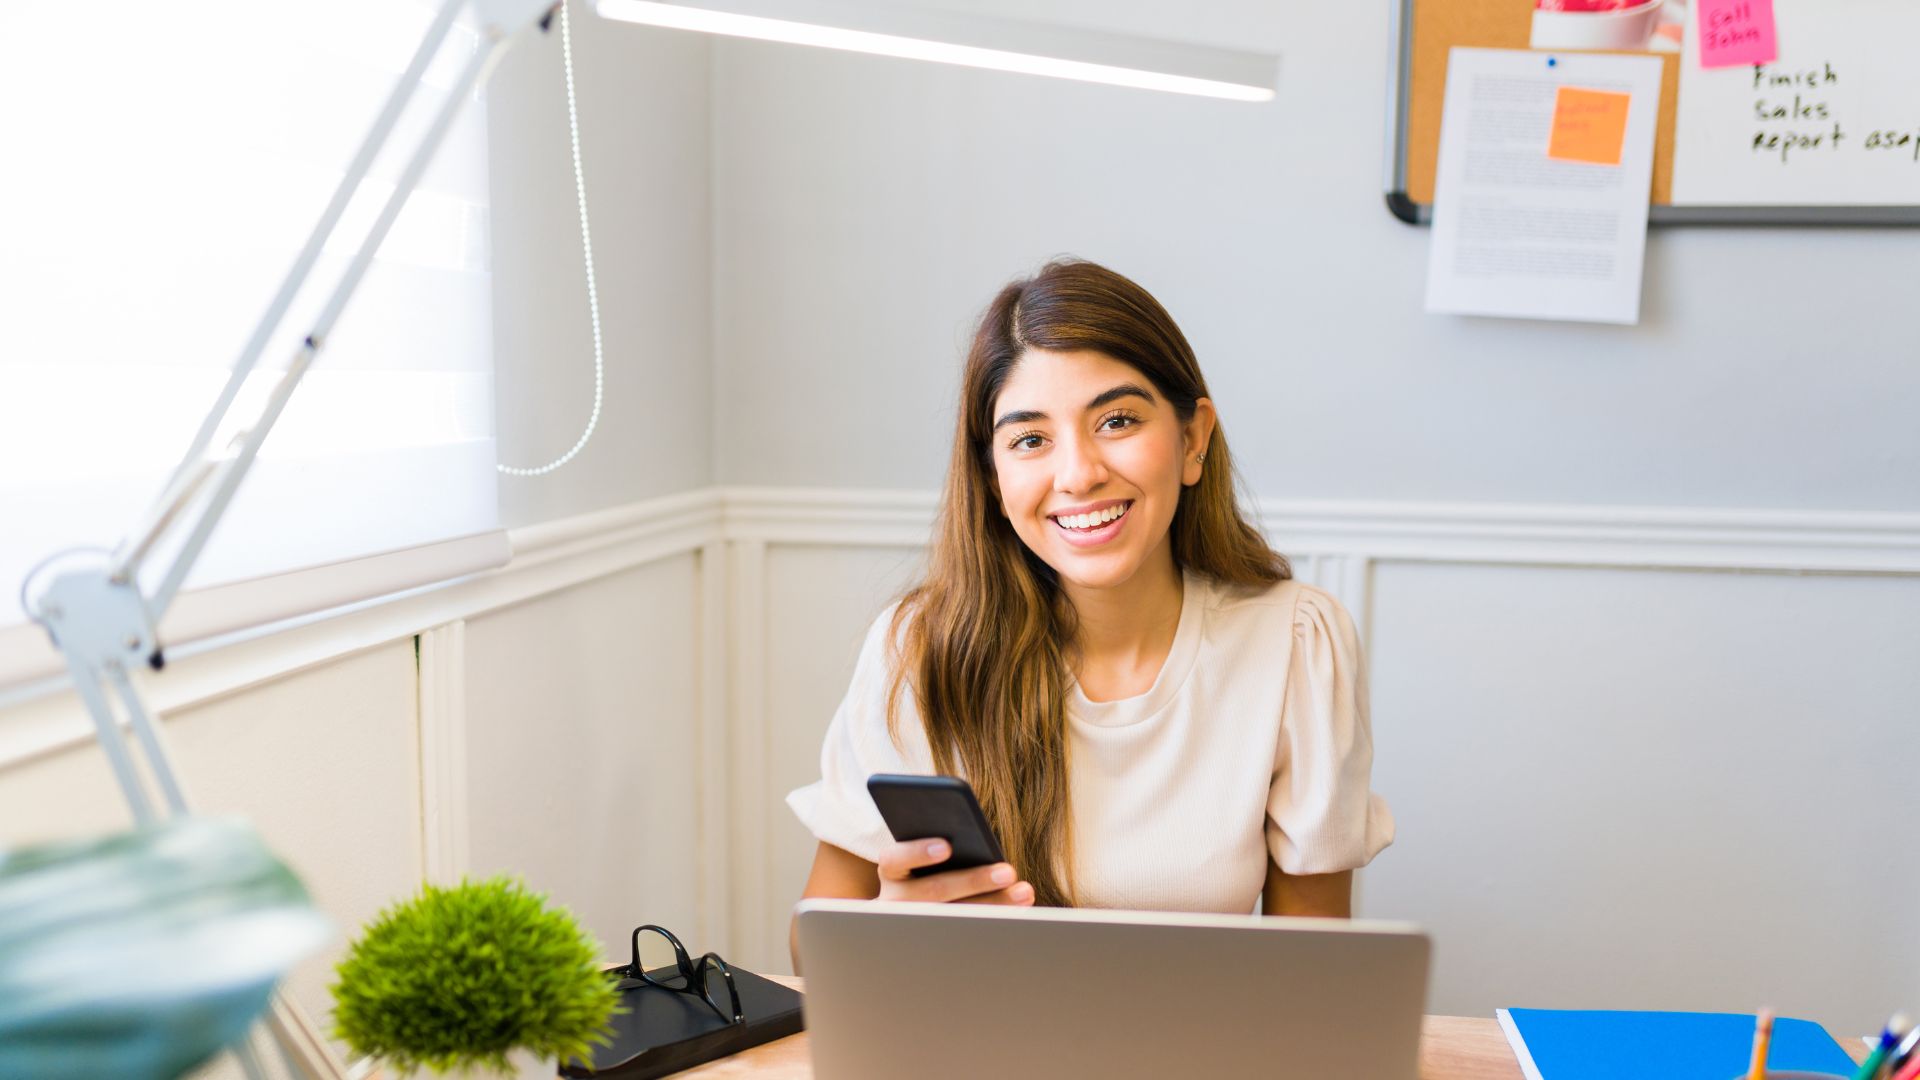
0,0,507,686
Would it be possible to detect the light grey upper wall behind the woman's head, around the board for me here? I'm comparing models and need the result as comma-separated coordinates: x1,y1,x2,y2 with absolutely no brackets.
712,0,1920,509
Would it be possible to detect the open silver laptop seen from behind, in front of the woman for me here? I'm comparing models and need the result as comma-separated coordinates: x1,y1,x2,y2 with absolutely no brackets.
799,899,1430,1080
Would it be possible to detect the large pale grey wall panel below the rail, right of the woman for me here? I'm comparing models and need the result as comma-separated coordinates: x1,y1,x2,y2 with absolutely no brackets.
1363,563,1920,1032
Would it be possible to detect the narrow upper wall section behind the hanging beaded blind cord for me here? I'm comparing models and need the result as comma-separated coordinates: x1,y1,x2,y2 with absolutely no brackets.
488,2,714,527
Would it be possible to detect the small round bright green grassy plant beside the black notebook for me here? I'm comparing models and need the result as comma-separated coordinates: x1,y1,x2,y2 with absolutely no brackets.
334,876,618,1072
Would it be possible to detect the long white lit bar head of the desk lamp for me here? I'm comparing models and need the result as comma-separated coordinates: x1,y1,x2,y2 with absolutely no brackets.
595,0,1279,102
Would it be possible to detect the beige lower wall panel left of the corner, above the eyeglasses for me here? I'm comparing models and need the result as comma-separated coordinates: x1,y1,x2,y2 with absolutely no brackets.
465,555,716,957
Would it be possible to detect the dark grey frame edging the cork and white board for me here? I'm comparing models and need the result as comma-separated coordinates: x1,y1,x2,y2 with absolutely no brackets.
1386,0,1920,227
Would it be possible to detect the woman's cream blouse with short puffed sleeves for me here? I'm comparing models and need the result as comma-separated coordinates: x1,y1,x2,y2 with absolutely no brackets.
787,573,1394,913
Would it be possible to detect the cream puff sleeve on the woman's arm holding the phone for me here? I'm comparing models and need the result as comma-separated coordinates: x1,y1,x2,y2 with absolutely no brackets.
787,607,933,863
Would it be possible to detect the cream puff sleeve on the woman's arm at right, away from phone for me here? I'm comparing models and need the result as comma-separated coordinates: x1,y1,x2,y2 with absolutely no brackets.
1265,586,1394,874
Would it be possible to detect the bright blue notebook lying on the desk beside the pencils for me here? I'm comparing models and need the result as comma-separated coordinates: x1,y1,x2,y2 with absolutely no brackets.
1498,1009,1855,1080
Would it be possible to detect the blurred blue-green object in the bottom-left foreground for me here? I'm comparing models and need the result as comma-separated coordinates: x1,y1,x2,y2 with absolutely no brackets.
0,817,330,1080
